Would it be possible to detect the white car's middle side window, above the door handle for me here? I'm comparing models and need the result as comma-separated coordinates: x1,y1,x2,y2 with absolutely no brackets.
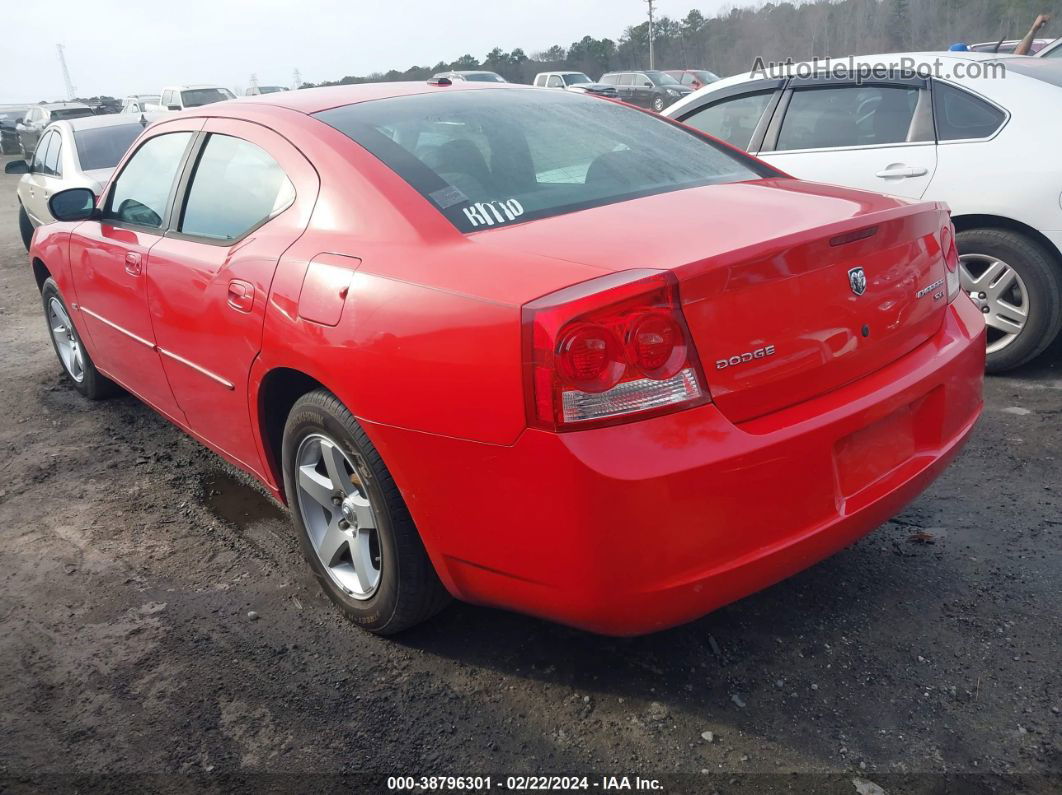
775,86,919,152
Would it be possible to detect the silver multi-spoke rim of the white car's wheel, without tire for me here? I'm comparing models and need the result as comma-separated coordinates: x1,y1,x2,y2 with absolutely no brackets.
959,254,1029,353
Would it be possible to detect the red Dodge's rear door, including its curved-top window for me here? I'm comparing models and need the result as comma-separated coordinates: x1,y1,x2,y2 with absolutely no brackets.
148,119,319,471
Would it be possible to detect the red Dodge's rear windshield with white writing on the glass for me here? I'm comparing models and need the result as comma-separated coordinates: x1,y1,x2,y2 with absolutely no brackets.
315,89,777,232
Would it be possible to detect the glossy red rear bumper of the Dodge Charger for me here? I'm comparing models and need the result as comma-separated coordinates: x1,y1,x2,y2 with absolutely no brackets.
364,296,984,635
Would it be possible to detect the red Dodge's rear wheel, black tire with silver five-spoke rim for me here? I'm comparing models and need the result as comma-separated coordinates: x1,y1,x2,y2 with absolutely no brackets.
281,390,449,635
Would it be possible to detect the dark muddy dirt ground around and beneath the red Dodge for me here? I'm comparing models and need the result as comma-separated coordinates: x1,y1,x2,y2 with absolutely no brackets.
0,157,1062,795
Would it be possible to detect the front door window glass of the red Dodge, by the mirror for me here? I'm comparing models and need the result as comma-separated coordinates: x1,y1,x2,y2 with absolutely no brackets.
104,133,192,229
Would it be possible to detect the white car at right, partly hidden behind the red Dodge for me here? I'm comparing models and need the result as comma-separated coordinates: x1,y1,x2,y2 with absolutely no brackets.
665,52,1062,371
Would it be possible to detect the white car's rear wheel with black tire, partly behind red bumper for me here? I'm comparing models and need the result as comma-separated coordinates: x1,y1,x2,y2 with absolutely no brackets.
956,228,1062,373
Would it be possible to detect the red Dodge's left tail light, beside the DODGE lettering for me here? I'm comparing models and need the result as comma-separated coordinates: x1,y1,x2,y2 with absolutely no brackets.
523,270,710,431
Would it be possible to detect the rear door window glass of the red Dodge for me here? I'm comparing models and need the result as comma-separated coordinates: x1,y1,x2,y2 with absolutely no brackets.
179,135,295,241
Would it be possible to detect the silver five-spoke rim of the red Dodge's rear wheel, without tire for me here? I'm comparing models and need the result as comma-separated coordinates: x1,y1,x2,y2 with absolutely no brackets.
295,433,382,600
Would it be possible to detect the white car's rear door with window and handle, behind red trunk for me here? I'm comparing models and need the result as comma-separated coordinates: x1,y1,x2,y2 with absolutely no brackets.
759,79,937,198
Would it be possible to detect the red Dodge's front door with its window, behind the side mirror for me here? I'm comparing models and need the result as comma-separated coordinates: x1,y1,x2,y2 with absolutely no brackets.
70,121,202,421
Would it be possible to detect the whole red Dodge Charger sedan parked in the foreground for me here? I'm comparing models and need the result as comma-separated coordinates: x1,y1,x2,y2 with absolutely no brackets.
31,81,984,635
